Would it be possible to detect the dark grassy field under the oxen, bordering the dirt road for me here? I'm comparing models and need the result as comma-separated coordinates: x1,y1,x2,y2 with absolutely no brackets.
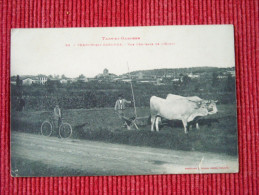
11,104,240,155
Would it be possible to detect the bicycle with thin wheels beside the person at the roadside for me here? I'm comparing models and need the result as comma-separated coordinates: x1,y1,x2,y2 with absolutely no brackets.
41,119,73,138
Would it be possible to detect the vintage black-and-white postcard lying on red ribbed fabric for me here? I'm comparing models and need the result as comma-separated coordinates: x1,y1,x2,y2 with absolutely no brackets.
10,25,238,177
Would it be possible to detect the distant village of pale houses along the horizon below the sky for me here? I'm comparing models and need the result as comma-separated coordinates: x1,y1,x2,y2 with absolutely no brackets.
11,68,235,86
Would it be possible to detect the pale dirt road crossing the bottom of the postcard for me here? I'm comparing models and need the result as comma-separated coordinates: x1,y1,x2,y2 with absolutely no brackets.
11,132,238,175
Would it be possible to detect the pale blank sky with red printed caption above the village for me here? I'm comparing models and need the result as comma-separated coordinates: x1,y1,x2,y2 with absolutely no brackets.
11,25,235,77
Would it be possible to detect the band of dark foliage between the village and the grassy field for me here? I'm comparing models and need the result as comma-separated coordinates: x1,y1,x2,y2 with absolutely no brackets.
11,68,238,110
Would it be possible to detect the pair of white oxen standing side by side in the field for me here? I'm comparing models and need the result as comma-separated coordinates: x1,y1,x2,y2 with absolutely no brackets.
150,94,217,133
